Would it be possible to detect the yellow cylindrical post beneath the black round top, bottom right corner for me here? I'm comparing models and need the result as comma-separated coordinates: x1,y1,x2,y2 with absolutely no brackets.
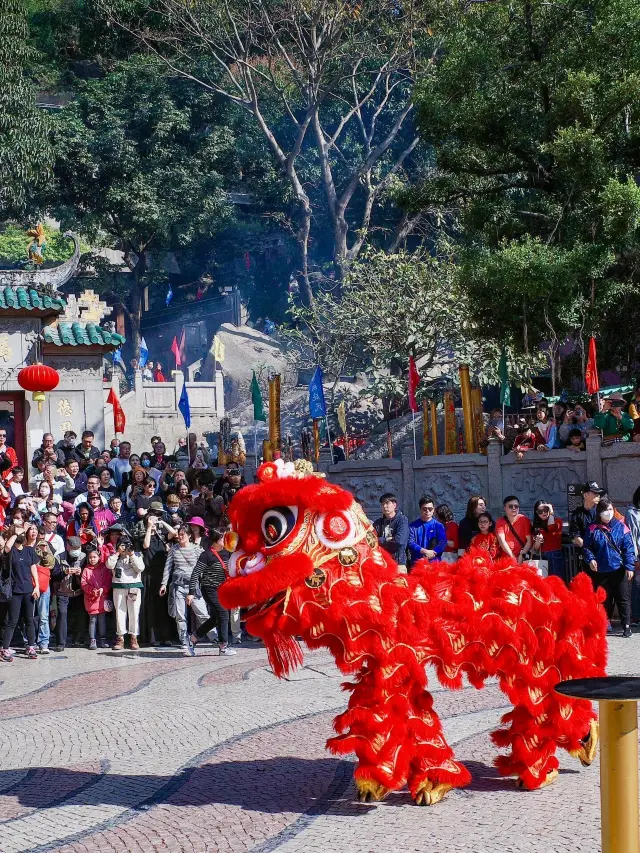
599,702,640,853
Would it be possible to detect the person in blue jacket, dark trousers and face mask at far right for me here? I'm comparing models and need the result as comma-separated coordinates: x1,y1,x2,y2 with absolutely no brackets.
584,498,635,638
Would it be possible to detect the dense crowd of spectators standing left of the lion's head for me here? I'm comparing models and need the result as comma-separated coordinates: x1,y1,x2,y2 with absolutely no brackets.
0,428,245,662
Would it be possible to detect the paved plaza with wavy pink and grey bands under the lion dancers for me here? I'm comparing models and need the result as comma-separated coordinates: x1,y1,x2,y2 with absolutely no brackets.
0,636,640,853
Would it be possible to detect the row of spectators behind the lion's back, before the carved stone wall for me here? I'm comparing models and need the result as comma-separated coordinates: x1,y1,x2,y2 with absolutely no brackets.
374,482,640,637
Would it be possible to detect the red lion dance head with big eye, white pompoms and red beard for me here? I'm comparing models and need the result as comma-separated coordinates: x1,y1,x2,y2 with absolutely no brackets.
220,459,388,674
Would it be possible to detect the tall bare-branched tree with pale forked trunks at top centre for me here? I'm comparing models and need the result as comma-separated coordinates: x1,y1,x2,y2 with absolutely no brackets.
104,0,437,303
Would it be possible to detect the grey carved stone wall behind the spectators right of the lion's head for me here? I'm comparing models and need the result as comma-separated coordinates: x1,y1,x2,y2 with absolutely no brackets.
321,434,640,520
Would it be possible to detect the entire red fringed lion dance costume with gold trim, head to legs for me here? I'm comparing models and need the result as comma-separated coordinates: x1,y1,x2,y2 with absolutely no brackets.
220,460,607,805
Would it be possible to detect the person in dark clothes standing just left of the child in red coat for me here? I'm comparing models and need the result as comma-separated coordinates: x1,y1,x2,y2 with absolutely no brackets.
51,536,87,652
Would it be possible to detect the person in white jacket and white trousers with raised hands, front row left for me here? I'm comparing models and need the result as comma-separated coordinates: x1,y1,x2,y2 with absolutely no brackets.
107,536,144,651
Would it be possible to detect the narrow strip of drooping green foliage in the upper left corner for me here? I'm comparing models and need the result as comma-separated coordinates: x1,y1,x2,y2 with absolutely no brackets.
0,0,51,217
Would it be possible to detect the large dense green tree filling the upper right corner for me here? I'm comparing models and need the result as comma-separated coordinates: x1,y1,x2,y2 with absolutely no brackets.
412,0,640,376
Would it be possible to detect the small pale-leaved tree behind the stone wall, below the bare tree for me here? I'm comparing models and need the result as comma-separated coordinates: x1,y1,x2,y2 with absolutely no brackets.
282,250,541,397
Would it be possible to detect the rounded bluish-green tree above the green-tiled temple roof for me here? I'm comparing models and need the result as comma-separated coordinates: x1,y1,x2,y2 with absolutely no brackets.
52,57,233,254
